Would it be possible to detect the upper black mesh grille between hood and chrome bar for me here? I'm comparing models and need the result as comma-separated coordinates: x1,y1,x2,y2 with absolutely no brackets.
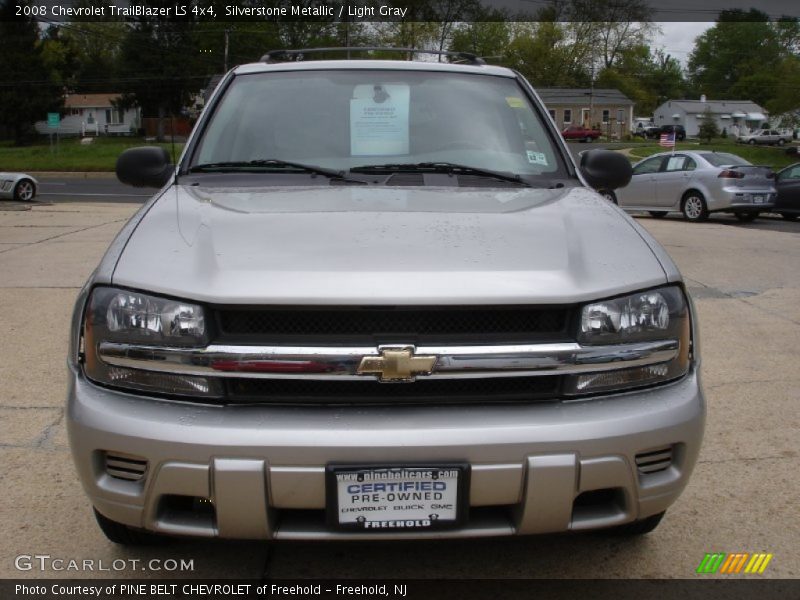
216,306,571,345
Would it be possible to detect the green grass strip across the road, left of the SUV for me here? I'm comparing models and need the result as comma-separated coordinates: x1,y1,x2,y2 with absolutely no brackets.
0,137,183,172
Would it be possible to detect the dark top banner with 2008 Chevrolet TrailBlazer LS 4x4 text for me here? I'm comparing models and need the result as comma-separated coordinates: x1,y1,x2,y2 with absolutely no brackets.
0,0,800,23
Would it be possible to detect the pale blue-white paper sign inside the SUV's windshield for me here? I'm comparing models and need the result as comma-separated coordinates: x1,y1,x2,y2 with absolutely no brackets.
350,84,410,156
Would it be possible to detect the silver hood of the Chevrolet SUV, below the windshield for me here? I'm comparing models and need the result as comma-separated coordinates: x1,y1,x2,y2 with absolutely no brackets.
112,186,667,305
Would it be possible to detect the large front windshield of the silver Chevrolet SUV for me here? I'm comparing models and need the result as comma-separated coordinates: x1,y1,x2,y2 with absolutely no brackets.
190,69,565,178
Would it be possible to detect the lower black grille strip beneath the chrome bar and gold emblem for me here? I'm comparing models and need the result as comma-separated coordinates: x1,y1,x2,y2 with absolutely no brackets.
227,375,561,405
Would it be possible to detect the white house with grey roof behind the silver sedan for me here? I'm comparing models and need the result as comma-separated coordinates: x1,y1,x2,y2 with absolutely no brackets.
653,96,769,136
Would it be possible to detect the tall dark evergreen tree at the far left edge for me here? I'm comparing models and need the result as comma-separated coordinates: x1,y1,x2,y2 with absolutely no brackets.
0,2,63,145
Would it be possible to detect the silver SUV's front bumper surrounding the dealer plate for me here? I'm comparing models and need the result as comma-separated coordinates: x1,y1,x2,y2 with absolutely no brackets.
67,368,705,539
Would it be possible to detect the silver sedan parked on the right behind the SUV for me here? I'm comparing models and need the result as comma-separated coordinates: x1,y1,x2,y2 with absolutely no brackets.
604,152,776,221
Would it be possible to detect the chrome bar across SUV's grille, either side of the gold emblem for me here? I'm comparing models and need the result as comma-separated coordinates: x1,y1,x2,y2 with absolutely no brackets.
97,340,680,381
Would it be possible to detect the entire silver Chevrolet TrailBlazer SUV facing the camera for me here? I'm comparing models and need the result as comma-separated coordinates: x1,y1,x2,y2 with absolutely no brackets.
67,49,705,544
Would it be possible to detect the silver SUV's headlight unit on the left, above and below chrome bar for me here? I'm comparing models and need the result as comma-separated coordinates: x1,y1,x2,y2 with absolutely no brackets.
84,287,222,398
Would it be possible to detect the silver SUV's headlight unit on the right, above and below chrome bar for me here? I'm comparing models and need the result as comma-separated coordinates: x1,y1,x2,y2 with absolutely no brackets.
566,286,691,395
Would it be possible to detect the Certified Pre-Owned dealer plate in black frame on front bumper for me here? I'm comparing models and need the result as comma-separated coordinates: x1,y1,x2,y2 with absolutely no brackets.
327,465,467,532
